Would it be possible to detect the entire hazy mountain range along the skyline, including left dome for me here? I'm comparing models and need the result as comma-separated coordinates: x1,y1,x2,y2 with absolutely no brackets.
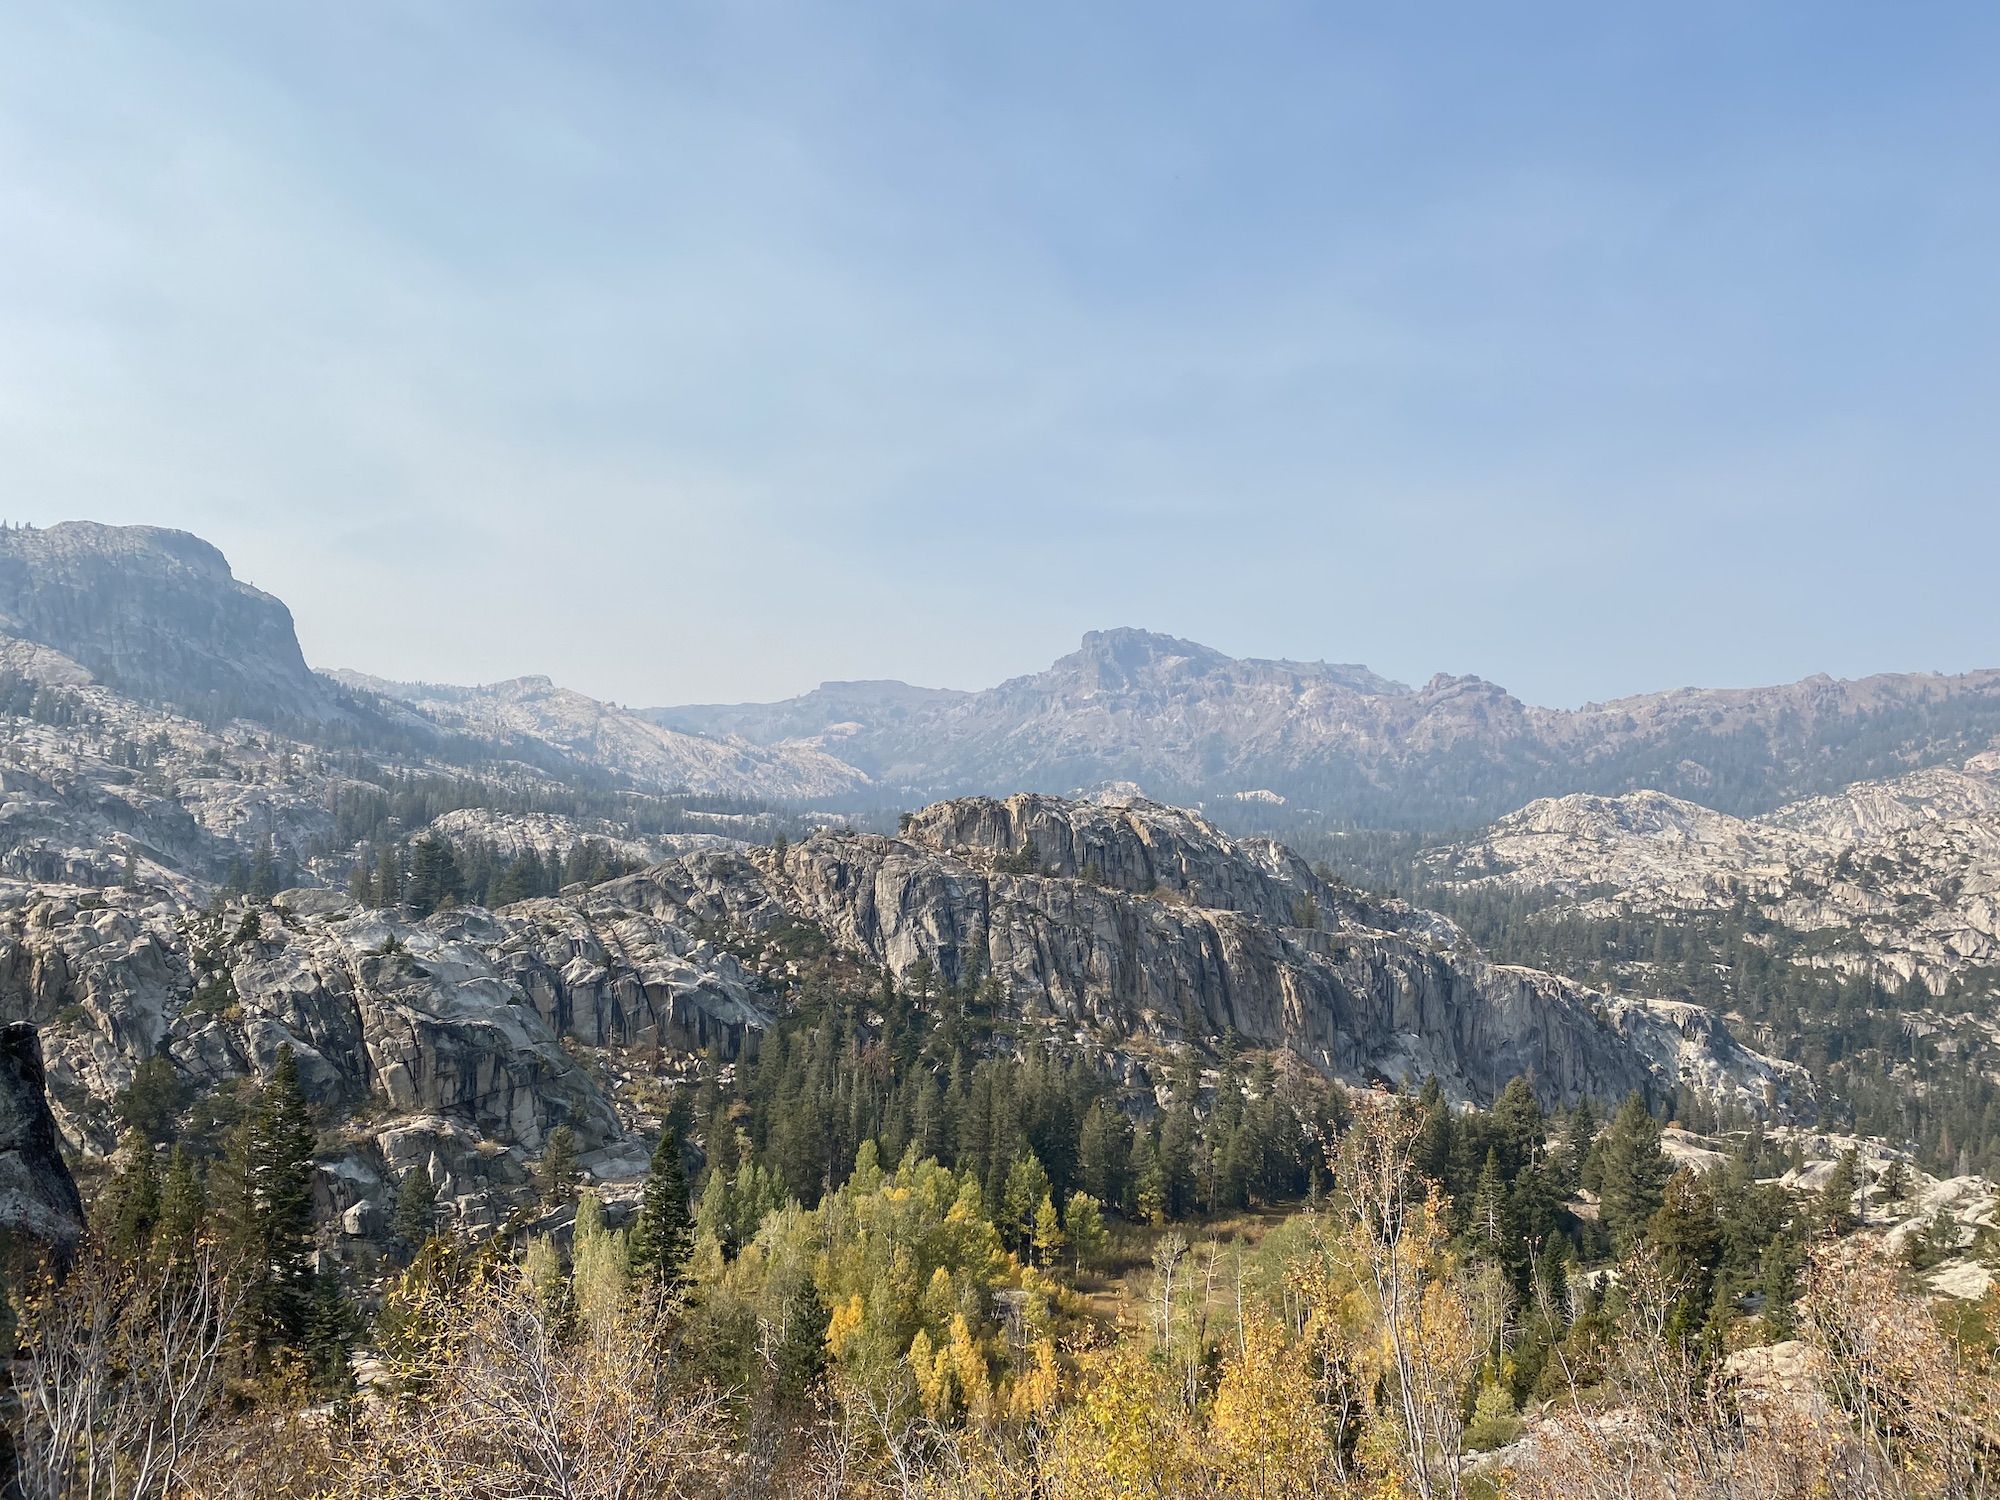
0,522,2000,830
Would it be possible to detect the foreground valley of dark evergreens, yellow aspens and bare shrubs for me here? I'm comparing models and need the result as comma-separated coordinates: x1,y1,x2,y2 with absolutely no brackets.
8,934,2000,1500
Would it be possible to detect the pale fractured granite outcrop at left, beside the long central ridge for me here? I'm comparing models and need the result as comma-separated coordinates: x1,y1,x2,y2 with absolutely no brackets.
0,866,772,1234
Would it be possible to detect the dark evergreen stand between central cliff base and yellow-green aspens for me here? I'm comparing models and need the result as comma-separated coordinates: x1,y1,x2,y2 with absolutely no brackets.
694,972,1340,1248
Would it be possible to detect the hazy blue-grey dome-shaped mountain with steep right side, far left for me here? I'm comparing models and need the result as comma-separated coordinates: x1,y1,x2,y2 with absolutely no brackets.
0,520,340,720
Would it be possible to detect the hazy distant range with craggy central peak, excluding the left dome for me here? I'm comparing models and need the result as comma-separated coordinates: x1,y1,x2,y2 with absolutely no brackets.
648,630,2000,828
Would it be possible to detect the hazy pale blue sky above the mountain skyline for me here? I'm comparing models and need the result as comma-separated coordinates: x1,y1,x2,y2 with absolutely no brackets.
0,0,2000,704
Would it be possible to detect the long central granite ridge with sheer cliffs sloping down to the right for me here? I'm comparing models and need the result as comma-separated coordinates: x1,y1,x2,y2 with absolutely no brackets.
750,796,1806,1108
